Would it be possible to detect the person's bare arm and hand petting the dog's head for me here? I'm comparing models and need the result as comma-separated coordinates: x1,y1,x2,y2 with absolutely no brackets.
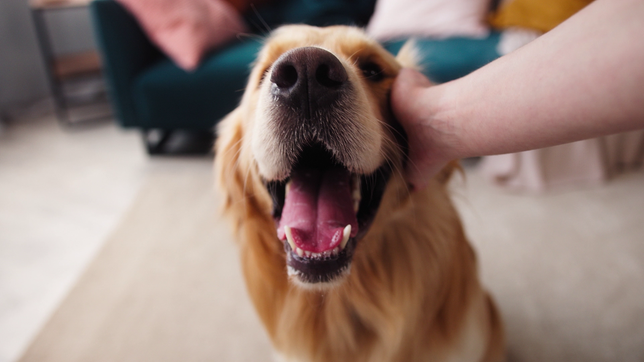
392,0,644,188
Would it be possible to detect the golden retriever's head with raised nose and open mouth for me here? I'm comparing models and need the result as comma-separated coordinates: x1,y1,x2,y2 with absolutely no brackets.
216,25,438,286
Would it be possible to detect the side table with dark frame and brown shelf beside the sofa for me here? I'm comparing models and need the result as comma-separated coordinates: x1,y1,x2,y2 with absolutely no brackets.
29,0,112,125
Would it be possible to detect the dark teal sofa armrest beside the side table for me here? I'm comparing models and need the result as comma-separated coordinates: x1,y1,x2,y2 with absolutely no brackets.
90,0,163,127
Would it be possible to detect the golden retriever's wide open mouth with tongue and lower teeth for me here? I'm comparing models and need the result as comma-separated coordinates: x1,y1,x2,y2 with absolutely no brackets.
266,144,391,283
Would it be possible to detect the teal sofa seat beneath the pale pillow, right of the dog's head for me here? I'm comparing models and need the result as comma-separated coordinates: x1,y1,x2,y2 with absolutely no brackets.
384,32,500,83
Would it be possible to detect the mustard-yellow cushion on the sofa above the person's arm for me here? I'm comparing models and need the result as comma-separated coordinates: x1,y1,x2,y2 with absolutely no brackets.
490,0,592,32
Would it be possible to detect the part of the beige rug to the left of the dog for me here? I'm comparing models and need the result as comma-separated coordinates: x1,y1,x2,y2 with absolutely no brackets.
21,160,272,362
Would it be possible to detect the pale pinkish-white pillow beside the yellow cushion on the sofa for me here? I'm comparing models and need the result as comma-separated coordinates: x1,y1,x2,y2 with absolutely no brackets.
367,0,490,40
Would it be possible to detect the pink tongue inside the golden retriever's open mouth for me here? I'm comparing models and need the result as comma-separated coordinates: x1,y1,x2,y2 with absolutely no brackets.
277,168,358,253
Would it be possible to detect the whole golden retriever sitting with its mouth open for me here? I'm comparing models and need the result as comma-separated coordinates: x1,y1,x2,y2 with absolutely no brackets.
215,25,503,362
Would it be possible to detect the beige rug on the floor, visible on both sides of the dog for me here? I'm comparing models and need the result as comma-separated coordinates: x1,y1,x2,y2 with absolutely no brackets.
21,163,644,362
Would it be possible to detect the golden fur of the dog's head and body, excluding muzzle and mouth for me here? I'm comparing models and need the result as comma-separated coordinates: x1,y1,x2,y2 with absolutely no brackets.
216,26,503,362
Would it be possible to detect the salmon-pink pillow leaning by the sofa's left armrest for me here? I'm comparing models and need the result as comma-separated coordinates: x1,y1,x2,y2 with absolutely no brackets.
118,0,246,71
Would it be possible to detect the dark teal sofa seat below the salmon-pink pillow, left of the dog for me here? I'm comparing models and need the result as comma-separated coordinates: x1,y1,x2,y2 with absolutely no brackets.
132,40,262,130
